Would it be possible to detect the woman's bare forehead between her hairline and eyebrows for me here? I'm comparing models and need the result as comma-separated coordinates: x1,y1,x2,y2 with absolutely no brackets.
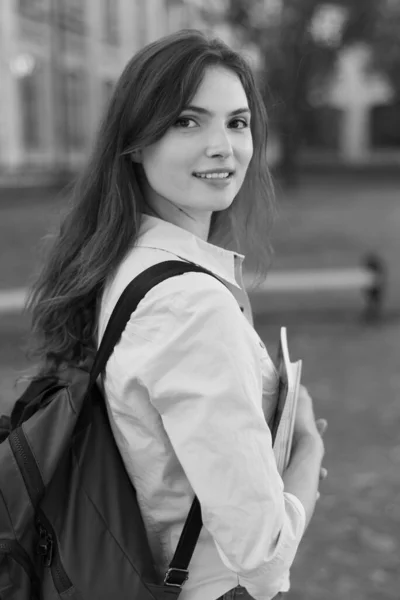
191,66,248,112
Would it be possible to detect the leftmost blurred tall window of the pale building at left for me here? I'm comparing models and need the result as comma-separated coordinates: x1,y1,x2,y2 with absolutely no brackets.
18,67,43,150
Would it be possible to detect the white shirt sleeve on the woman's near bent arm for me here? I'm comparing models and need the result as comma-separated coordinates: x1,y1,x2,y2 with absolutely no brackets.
120,273,305,600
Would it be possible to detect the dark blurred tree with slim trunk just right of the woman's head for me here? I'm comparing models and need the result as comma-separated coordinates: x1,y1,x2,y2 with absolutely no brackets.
202,0,400,184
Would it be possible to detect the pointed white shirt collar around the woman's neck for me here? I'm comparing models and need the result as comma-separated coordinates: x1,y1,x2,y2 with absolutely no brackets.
136,215,244,288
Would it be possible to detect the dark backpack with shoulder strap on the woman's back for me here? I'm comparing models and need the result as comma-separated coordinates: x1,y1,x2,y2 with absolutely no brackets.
0,260,219,600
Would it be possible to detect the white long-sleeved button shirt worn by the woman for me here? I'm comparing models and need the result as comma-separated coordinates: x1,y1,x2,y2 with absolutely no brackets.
99,216,305,600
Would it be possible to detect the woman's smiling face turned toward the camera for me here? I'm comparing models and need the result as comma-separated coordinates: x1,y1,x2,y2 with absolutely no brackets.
140,67,253,234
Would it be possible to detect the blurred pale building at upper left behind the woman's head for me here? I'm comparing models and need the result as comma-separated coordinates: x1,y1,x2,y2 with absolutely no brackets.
0,0,206,184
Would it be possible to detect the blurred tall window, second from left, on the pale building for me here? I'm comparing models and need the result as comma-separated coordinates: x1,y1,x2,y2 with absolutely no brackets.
62,71,87,150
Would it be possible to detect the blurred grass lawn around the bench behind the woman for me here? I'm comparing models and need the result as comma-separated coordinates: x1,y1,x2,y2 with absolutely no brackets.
0,178,400,600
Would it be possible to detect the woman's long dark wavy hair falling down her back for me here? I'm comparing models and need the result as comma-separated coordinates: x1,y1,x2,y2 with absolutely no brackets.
27,30,273,370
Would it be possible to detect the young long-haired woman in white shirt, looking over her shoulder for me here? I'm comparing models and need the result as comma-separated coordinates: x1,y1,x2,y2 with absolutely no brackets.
31,31,323,600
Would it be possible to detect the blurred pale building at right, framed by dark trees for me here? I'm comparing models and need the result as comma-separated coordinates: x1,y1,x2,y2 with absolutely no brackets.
306,43,400,165
